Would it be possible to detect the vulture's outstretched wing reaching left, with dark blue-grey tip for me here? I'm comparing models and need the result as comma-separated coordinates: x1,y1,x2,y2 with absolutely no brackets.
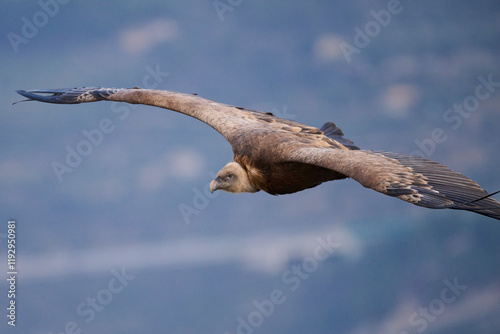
17,87,350,149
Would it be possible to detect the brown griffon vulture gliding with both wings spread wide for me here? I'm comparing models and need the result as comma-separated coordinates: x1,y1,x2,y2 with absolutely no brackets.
17,87,500,220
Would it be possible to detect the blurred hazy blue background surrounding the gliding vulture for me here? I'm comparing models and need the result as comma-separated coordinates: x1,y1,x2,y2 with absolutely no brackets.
0,0,500,334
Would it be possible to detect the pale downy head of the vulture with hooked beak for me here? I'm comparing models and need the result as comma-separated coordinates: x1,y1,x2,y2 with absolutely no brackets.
210,161,259,193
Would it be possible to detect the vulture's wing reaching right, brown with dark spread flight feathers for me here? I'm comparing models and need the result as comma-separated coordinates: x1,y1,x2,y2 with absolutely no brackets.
288,147,500,219
